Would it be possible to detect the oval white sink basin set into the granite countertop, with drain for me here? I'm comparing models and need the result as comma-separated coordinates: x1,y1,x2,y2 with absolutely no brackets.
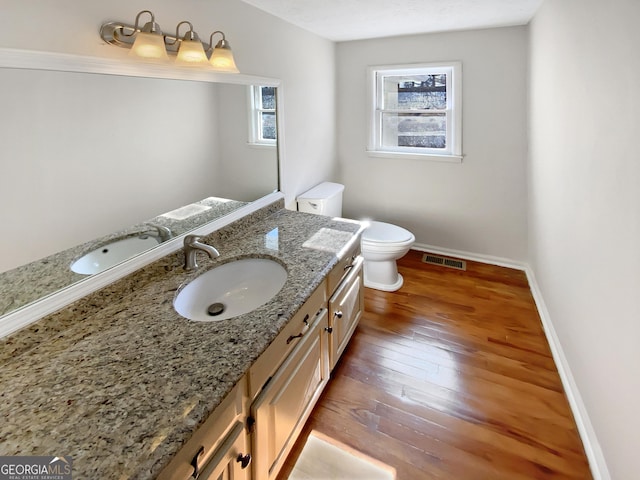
173,258,287,322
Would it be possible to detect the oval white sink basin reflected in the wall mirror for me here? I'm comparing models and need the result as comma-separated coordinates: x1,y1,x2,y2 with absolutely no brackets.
71,235,160,275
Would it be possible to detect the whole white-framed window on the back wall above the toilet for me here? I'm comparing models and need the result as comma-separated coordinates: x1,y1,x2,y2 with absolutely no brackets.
369,63,462,160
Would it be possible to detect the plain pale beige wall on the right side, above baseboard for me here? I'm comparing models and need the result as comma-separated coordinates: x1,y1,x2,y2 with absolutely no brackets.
528,0,640,480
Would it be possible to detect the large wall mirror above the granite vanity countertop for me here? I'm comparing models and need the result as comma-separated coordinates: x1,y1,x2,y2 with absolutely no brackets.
0,49,279,326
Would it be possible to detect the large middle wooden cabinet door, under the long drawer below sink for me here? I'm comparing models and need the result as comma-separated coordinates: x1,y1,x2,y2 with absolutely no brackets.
251,308,329,480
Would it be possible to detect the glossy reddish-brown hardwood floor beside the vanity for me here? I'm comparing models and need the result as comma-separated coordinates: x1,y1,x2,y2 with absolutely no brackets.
279,250,592,480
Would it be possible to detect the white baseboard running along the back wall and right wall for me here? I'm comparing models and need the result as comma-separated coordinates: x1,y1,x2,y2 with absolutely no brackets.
412,244,611,480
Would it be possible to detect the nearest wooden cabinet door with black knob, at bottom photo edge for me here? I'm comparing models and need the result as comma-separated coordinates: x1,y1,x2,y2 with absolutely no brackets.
196,422,251,480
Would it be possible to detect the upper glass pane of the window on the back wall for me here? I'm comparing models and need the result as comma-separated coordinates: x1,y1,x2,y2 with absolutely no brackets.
383,73,447,110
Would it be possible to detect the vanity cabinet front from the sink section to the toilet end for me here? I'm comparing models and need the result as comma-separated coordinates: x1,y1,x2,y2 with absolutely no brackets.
249,242,364,480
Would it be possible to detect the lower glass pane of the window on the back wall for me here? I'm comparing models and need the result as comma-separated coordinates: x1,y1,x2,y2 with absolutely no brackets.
382,113,447,148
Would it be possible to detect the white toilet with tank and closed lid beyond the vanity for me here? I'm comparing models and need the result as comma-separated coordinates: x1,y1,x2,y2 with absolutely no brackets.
297,182,416,292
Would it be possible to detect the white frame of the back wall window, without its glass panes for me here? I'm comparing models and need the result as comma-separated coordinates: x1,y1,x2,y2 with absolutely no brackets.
367,62,463,162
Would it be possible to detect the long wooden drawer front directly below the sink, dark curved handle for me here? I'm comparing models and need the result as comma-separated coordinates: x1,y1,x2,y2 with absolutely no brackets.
249,281,327,400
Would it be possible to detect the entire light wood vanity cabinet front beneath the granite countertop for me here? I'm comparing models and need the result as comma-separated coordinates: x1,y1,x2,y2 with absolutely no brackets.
159,218,364,480
